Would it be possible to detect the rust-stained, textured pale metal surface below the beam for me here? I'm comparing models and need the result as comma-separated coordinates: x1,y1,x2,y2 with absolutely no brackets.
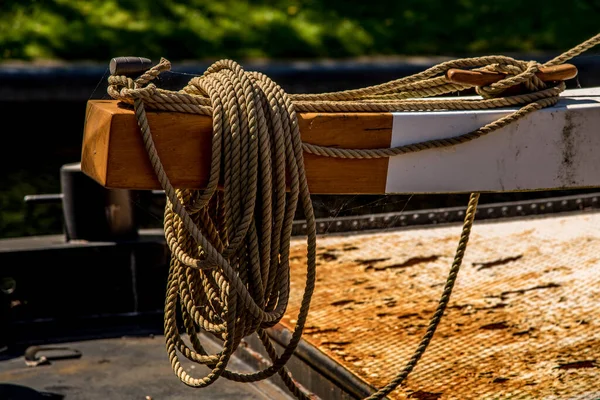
282,212,600,400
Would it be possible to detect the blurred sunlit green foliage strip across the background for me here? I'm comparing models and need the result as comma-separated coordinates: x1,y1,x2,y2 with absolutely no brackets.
0,0,600,61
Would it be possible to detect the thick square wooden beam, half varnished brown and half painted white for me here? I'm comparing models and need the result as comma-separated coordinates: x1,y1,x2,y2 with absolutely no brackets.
81,88,600,194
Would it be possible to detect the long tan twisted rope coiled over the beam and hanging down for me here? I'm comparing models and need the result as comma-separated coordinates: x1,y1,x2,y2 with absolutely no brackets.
108,34,600,399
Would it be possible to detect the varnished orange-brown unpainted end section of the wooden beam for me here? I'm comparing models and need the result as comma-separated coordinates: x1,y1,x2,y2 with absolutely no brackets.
81,100,393,194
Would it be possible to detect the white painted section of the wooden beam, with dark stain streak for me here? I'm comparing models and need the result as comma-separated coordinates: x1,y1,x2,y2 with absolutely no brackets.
386,88,600,193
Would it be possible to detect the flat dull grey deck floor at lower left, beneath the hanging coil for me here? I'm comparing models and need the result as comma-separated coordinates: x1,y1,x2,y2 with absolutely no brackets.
0,335,293,400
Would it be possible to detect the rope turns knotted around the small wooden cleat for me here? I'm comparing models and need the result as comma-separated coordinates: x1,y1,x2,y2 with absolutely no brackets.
475,61,547,99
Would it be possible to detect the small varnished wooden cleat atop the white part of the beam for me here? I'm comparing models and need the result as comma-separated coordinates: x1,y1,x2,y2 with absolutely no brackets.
446,64,577,86
